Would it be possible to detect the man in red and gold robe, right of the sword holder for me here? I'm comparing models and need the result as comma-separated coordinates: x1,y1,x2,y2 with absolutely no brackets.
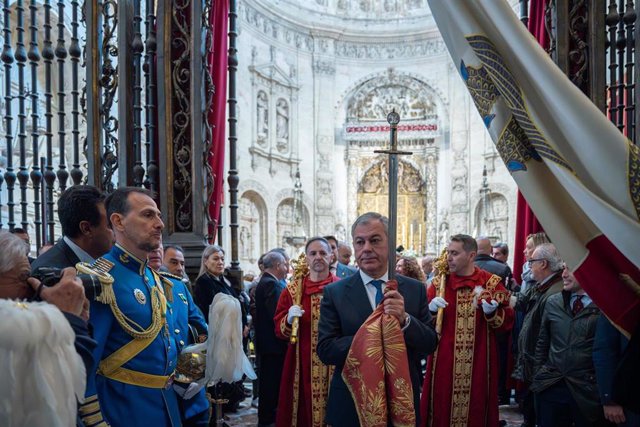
420,234,514,427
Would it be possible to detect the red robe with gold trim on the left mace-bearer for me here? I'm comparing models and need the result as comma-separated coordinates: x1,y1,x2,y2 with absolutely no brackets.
273,274,339,427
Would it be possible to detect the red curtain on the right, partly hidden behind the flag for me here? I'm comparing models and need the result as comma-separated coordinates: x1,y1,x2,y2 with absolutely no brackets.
513,0,549,282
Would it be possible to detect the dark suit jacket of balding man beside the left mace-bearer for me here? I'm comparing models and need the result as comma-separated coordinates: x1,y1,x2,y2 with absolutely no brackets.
254,273,287,355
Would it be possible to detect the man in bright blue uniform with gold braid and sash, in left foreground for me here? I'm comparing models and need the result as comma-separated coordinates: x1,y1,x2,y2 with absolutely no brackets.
80,187,183,427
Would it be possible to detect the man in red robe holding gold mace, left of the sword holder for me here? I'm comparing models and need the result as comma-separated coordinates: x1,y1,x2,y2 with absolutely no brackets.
274,237,338,427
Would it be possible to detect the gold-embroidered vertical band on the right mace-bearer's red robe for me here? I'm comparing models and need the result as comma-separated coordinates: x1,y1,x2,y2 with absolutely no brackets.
450,288,476,427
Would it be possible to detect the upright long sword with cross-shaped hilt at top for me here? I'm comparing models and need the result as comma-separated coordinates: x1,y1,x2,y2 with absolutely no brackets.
374,108,413,280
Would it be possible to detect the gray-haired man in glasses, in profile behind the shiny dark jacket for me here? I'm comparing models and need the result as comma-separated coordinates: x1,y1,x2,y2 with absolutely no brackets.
513,243,564,425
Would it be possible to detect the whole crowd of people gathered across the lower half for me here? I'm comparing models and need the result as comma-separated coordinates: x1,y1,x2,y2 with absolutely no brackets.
0,185,640,427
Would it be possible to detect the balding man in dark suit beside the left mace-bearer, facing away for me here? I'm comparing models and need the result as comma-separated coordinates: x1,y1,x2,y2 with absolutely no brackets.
254,251,289,426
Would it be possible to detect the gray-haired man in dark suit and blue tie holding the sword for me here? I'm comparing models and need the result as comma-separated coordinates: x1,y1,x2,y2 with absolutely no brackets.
317,212,438,427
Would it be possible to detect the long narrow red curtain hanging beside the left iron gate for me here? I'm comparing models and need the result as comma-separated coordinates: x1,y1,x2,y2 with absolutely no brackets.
208,0,229,243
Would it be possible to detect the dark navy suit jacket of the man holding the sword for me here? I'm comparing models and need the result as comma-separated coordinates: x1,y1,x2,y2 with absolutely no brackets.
317,274,438,427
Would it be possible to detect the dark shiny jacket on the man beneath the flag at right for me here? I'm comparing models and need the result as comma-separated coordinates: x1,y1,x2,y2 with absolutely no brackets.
531,291,603,426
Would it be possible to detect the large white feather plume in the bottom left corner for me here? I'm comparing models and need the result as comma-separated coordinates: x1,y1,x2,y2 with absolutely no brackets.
0,300,86,427
